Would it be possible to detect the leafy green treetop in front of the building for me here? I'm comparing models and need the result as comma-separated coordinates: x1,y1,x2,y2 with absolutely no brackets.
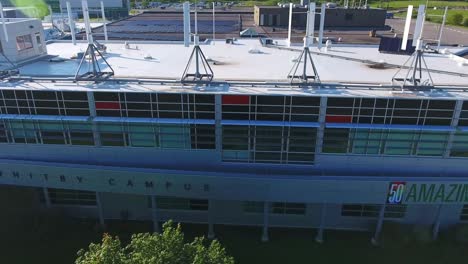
75,221,234,264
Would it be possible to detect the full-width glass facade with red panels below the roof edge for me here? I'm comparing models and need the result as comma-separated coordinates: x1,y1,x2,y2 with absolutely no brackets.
0,92,468,165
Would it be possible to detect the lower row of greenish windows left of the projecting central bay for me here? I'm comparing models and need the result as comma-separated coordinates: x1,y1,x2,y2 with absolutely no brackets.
0,120,215,149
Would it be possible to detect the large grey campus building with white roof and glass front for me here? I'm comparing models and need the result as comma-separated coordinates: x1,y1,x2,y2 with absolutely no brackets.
0,17,468,243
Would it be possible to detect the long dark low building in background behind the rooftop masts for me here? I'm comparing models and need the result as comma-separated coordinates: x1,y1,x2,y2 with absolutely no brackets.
254,6,387,28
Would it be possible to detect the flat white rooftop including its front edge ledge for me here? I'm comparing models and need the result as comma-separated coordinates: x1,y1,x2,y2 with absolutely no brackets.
0,39,468,99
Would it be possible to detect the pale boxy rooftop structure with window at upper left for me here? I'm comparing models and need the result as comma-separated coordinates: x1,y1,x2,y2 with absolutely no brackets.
0,18,47,63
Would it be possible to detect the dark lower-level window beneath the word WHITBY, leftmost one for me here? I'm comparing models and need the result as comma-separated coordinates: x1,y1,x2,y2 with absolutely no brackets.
47,188,96,206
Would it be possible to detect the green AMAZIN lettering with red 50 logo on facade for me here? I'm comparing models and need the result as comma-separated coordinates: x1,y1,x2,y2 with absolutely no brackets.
387,182,468,204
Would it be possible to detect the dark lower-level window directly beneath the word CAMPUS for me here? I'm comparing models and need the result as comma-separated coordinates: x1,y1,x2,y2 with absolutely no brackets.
154,196,208,211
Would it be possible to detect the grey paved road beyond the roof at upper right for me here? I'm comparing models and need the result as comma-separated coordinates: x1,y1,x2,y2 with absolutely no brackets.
386,18,468,46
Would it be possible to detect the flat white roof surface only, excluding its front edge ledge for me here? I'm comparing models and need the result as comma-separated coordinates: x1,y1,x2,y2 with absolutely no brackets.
12,39,468,85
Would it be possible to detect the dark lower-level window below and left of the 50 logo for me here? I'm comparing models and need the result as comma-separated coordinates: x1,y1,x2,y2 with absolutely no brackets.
341,204,407,219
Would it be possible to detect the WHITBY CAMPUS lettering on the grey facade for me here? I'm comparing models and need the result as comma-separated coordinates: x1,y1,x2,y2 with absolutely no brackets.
0,170,210,192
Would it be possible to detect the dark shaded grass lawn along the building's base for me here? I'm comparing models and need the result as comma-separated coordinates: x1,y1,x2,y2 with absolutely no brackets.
0,219,468,264
